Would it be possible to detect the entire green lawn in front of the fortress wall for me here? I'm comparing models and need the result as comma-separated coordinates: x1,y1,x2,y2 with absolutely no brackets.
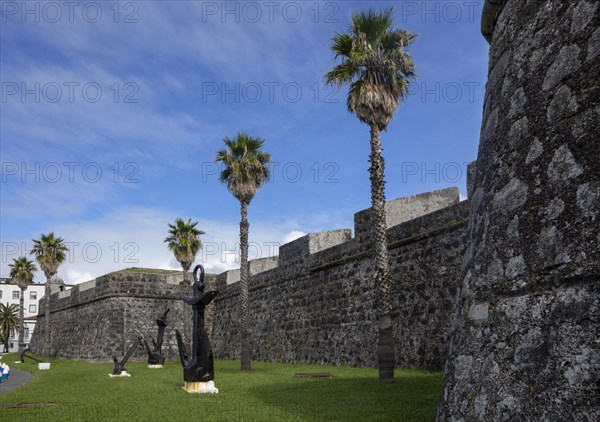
0,354,442,422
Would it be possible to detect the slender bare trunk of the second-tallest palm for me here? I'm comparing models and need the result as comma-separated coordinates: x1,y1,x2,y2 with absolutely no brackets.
240,201,251,371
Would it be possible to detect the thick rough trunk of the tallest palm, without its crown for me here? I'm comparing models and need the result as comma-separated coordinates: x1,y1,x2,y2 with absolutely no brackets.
369,125,395,383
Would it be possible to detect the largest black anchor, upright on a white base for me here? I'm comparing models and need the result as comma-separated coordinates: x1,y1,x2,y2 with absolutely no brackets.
175,265,219,393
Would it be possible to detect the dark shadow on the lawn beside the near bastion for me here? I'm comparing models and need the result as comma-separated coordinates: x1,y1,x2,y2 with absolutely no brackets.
252,373,441,422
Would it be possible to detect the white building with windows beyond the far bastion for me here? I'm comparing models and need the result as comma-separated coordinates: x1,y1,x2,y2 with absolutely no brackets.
0,278,46,352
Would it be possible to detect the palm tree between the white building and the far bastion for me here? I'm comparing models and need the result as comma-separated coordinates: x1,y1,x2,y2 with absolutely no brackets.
31,232,67,354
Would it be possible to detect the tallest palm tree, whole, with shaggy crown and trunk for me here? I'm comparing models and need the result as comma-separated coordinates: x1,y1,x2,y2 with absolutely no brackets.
325,8,416,382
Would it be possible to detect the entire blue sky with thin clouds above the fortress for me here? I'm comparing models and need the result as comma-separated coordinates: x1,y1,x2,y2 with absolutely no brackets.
0,1,488,283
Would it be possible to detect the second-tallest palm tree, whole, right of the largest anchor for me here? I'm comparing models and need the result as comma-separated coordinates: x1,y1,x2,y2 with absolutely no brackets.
215,132,271,371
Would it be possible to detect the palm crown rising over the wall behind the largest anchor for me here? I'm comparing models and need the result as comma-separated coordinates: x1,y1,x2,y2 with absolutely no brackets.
165,218,205,285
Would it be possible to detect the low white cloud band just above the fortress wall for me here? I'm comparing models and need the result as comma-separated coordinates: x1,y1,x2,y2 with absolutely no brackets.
2,207,312,284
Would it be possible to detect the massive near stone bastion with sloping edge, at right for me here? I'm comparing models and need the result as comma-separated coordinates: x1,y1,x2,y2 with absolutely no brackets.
438,0,600,421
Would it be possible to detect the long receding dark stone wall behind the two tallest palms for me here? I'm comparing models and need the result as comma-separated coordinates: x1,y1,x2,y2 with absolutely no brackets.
213,201,468,370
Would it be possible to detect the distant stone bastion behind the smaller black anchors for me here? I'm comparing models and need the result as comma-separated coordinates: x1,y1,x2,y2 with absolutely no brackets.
30,272,214,360
